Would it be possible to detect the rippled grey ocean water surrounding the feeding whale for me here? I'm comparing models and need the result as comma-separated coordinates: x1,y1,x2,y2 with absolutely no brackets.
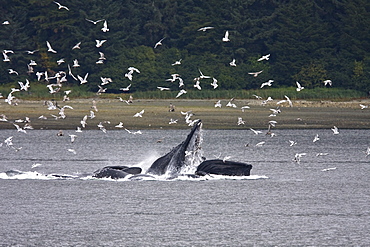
0,129,370,246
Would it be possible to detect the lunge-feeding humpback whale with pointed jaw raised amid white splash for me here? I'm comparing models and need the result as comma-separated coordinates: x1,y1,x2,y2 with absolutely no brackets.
93,120,252,179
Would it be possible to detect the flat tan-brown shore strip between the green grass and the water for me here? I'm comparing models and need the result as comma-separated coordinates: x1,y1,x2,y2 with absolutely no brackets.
0,92,370,130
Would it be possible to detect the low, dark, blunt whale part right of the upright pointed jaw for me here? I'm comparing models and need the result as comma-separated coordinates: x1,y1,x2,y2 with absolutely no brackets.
195,159,252,176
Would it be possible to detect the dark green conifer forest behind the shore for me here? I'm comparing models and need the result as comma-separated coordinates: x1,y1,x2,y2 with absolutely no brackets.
0,0,370,93
